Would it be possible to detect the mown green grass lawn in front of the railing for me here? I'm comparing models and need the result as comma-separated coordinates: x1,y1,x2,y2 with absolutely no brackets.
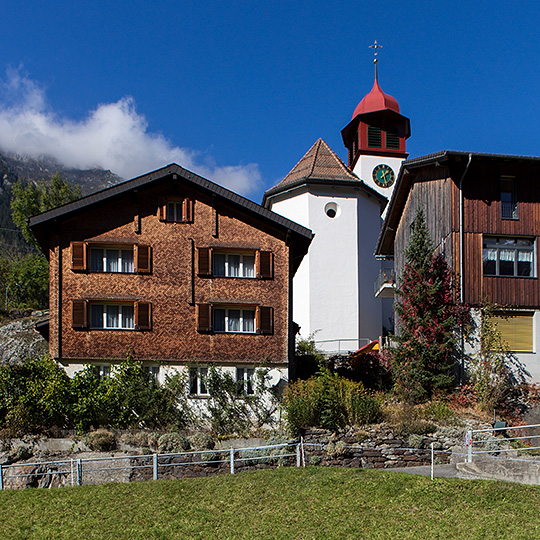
0,467,540,540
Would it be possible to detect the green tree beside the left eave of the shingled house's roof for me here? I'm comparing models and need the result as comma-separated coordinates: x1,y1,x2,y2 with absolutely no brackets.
10,172,81,248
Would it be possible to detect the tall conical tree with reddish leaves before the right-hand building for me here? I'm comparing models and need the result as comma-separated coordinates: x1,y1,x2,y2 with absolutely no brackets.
392,209,469,403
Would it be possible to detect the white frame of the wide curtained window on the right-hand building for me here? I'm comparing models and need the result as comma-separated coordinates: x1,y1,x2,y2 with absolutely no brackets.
482,236,536,278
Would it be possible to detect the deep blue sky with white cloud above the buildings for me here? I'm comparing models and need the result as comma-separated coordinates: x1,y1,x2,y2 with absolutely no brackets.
0,0,540,202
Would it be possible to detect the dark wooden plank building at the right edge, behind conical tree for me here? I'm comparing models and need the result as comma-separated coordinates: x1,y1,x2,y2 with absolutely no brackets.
376,151,540,382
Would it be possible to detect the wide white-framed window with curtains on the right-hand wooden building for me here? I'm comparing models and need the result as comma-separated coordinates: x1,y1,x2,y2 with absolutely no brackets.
482,236,535,277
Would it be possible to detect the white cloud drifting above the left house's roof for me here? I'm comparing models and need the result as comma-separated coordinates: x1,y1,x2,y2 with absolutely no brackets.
0,70,261,195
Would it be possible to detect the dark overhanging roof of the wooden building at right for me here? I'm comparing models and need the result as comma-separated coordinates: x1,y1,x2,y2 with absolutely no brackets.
375,150,540,257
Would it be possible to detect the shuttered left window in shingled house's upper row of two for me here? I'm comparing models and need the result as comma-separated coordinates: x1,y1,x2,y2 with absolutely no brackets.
71,242,151,274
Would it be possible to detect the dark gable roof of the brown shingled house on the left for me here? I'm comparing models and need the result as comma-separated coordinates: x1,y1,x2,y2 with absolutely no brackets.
29,163,313,258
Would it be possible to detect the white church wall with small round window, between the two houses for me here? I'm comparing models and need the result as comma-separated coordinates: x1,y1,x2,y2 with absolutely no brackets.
271,182,382,351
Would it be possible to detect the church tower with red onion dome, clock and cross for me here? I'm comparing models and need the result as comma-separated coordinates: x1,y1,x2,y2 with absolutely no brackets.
341,42,411,200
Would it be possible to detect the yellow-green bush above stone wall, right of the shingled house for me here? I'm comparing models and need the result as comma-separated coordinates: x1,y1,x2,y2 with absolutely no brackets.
283,370,381,433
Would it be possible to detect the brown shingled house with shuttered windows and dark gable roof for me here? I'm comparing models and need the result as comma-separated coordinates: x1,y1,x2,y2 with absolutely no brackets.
30,164,312,395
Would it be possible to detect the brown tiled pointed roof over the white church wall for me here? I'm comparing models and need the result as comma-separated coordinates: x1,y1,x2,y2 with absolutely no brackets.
262,139,387,206
